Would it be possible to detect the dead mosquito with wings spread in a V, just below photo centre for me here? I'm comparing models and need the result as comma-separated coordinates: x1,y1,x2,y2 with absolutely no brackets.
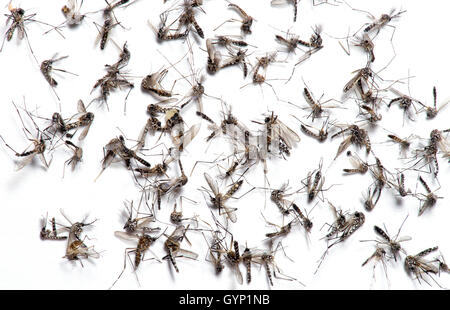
203,172,243,223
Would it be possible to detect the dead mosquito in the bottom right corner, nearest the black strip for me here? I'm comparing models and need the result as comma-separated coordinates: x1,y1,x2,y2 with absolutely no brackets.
405,246,439,285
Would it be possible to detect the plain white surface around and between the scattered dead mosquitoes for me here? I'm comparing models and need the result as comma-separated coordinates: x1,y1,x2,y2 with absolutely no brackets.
0,0,450,289
